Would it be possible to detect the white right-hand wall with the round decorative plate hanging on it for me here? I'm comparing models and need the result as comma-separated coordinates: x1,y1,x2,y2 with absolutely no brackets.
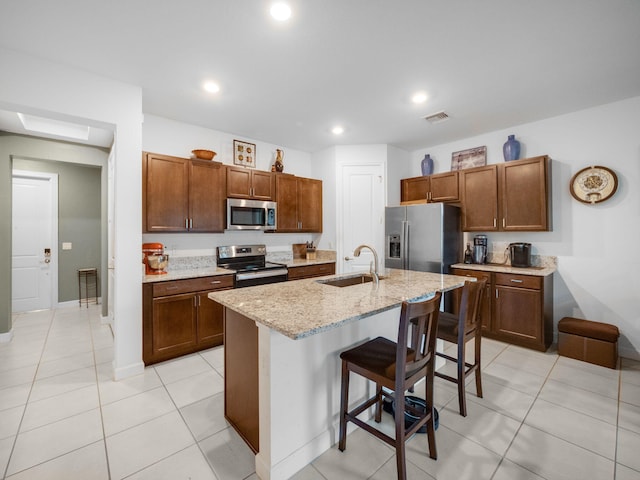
410,97,640,358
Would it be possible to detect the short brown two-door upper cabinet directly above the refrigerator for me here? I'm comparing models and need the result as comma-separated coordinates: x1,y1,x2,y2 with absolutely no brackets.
400,171,460,202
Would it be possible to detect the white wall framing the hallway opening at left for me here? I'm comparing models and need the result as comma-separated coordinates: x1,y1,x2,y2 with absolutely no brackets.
0,48,144,378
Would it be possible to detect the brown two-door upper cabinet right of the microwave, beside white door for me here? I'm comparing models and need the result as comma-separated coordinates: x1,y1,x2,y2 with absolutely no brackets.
275,173,322,233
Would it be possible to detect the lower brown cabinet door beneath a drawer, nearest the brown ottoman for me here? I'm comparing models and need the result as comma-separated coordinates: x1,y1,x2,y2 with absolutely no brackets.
494,285,542,344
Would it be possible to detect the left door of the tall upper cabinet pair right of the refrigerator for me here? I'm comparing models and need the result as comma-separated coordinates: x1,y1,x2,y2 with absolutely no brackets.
460,165,498,232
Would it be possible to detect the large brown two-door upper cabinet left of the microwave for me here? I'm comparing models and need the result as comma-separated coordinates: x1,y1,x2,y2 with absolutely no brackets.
142,152,226,232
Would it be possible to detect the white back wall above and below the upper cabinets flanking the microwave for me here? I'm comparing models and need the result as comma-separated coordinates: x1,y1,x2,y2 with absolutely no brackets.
142,114,318,256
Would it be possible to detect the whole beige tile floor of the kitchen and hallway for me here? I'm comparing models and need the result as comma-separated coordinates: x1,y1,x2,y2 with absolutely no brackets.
0,307,640,480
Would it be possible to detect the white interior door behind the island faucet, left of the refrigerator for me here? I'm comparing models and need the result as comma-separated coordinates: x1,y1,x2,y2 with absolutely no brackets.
338,165,385,273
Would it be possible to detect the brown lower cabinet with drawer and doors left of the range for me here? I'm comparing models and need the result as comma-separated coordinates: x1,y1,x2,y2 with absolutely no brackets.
142,275,233,365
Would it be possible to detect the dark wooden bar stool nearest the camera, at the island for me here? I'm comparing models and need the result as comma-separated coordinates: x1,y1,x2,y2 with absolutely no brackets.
338,292,441,480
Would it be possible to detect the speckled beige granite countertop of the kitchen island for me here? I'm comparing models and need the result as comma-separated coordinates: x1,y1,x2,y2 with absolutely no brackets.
209,269,468,340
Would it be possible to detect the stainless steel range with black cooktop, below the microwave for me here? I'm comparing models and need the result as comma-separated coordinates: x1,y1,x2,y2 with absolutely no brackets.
216,245,288,288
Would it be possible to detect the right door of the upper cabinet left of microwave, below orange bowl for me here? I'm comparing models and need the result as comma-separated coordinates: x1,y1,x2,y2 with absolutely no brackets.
189,160,226,232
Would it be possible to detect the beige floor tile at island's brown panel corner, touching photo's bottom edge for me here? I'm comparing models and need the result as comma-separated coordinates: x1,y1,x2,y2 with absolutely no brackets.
198,428,256,479
